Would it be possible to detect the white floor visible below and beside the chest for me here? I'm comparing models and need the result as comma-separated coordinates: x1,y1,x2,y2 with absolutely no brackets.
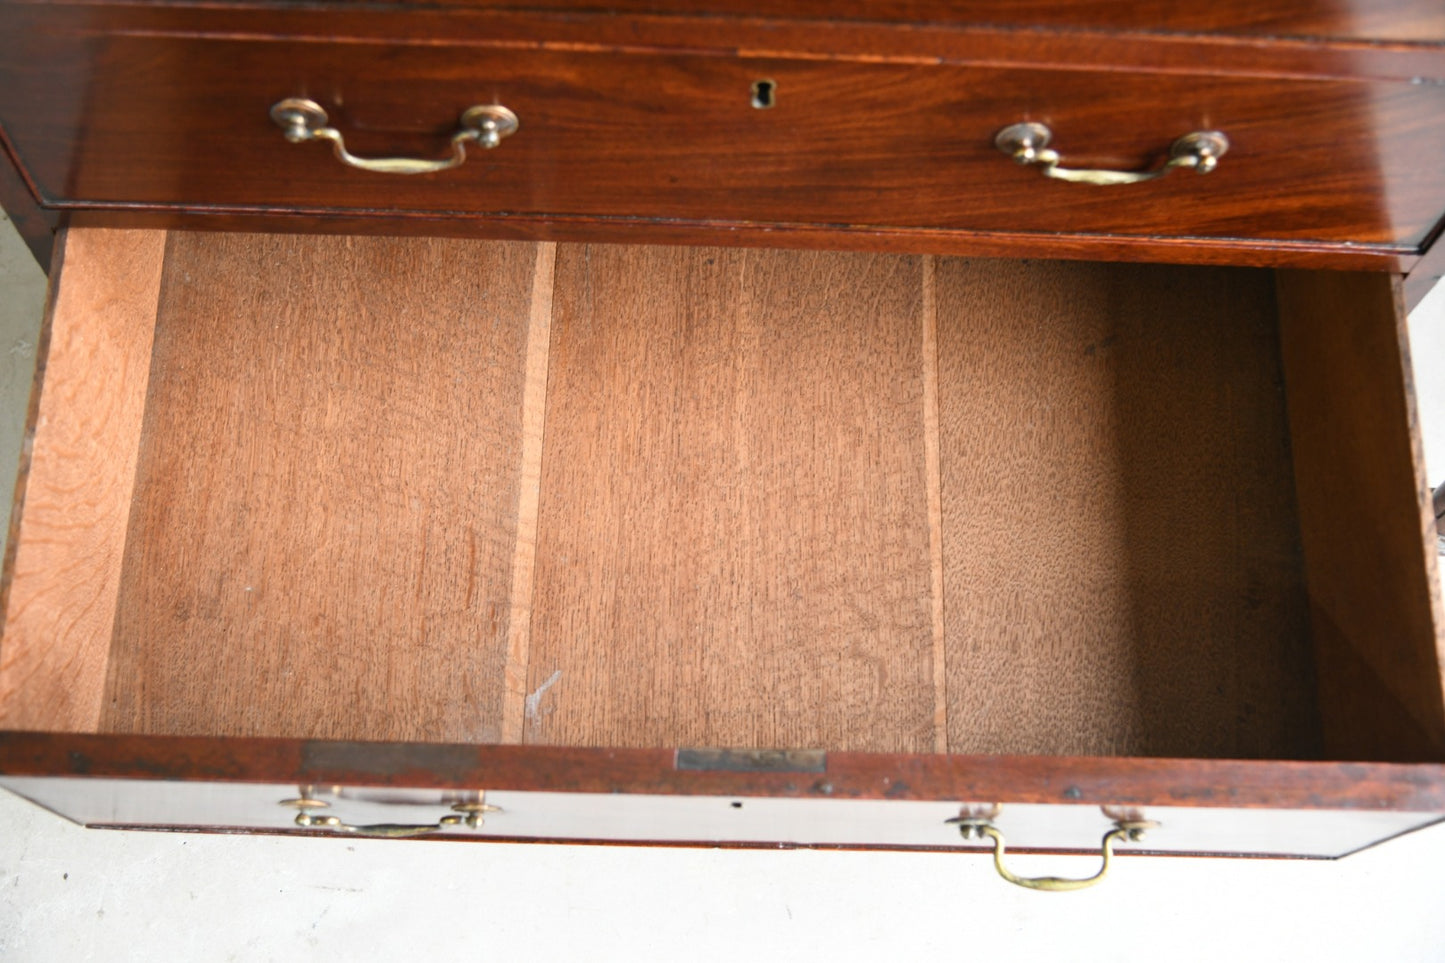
0,214,1445,963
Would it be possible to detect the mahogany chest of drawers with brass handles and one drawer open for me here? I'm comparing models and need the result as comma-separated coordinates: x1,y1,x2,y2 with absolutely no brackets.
0,0,1445,888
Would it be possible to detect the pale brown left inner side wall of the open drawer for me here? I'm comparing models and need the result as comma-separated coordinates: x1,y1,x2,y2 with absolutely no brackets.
0,230,166,730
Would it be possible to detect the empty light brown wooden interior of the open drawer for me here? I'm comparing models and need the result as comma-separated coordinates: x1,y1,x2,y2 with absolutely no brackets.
0,230,1445,759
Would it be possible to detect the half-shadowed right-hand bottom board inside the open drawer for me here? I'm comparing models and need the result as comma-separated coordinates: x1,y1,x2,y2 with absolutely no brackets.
938,260,1319,758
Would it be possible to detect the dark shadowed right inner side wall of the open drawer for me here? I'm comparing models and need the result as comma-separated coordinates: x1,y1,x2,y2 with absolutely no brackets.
1279,272,1445,761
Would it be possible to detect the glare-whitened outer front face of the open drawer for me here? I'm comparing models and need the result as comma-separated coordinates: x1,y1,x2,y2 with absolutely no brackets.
0,776,1441,857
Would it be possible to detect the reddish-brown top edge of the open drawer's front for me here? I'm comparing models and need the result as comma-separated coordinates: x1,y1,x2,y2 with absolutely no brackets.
0,732,1445,813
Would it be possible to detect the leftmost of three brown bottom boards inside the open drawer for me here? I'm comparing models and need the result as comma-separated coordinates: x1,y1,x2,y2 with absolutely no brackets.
103,234,538,742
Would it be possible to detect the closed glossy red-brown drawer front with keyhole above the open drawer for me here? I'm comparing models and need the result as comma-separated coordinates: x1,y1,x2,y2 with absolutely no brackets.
8,22,1445,254
